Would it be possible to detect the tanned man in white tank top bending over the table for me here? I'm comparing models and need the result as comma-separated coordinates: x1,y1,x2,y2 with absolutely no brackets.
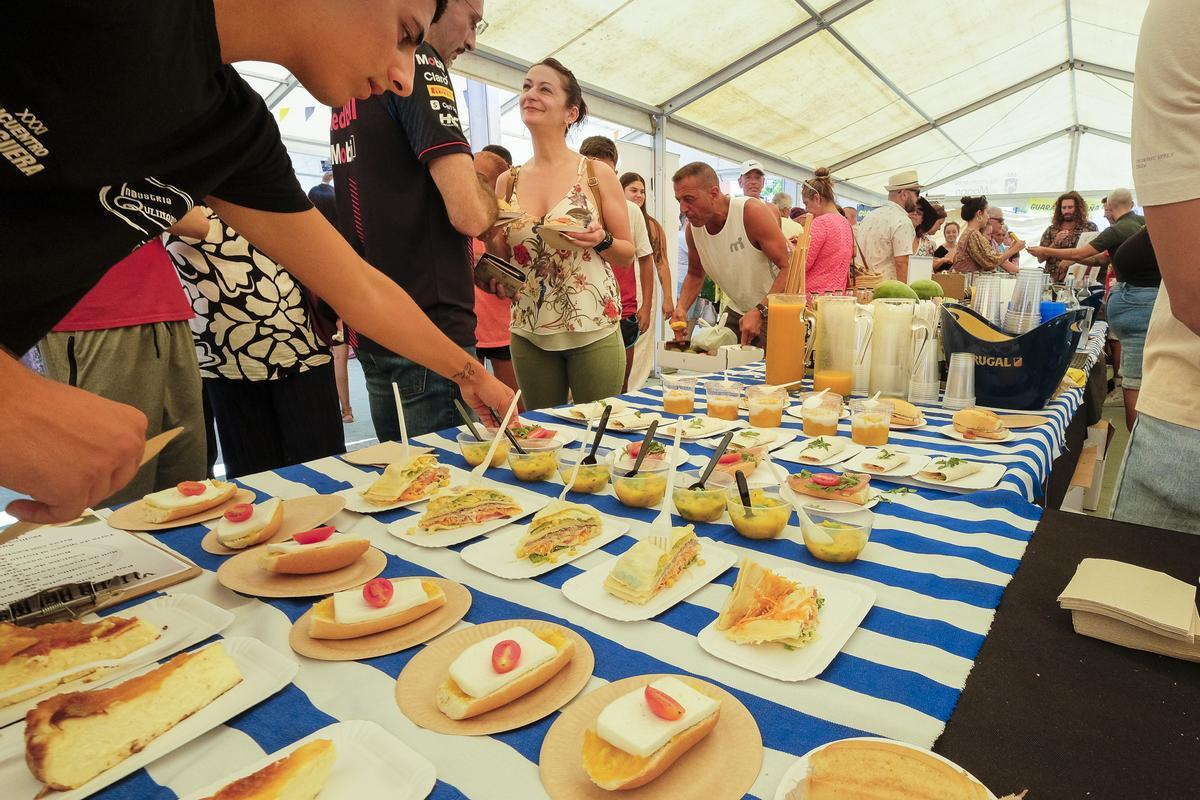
671,161,787,347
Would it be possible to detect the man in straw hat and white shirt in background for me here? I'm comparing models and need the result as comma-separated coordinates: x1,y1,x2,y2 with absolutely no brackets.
854,169,920,289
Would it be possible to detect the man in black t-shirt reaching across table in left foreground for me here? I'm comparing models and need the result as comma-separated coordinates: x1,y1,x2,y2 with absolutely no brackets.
0,0,512,532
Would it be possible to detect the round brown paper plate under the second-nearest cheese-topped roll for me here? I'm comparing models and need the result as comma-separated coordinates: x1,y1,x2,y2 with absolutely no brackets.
396,619,595,736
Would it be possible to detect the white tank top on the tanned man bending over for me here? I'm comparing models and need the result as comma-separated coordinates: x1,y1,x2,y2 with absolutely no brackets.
691,197,779,314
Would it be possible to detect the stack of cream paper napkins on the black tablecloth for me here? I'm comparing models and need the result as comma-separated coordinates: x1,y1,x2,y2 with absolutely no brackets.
1058,559,1200,661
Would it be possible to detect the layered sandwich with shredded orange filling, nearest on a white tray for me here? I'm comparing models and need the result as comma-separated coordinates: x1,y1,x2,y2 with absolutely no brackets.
716,559,824,648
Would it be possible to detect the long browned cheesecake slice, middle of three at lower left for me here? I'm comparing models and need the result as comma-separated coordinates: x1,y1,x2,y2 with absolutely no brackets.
25,642,241,789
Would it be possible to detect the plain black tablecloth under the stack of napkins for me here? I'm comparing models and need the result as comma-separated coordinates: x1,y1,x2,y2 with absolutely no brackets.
934,510,1200,800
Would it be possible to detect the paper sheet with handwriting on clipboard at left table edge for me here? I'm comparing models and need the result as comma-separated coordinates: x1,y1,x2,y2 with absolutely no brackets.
0,522,193,604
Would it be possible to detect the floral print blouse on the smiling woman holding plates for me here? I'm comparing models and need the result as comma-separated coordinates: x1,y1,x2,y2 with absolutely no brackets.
508,158,624,349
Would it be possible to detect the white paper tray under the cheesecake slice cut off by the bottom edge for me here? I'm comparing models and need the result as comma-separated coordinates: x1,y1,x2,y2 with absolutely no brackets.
182,720,438,800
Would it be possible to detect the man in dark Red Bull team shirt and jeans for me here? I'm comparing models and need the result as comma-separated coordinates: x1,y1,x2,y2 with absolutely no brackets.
329,0,497,441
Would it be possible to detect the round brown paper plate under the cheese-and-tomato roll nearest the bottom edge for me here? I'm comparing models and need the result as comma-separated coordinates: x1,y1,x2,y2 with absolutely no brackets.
538,674,763,800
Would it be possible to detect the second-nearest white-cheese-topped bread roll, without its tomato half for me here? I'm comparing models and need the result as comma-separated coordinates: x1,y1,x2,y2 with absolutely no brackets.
437,625,575,720
